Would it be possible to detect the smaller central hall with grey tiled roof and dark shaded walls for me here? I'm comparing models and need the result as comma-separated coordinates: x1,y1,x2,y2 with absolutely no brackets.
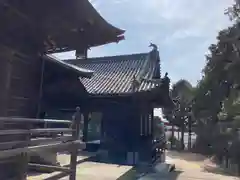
65,47,172,164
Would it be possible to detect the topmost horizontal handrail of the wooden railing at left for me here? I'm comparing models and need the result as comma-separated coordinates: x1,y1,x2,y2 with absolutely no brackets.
0,117,72,124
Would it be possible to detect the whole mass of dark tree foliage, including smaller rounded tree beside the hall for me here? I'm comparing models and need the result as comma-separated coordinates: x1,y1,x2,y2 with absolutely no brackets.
163,0,240,159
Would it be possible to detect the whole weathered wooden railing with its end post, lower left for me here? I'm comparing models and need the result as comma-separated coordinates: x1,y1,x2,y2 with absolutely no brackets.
0,110,85,180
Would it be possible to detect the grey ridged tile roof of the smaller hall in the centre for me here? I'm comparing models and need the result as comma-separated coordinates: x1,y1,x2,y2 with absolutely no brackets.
67,49,160,94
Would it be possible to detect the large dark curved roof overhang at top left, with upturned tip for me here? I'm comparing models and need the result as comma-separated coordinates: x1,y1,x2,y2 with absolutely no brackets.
2,0,125,53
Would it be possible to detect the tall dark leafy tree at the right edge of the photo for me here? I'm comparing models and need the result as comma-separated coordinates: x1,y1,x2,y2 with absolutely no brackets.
192,0,240,159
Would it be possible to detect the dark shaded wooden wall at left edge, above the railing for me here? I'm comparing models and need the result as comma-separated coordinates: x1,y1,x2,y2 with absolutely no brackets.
0,45,41,117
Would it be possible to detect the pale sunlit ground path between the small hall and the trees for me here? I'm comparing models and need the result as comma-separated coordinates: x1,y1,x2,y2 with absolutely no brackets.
139,151,240,180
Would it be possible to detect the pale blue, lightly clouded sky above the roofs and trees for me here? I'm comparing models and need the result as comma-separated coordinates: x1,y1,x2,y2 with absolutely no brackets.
54,0,233,85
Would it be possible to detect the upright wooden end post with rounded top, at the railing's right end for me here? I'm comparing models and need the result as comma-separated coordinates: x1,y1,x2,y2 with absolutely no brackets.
69,107,81,180
